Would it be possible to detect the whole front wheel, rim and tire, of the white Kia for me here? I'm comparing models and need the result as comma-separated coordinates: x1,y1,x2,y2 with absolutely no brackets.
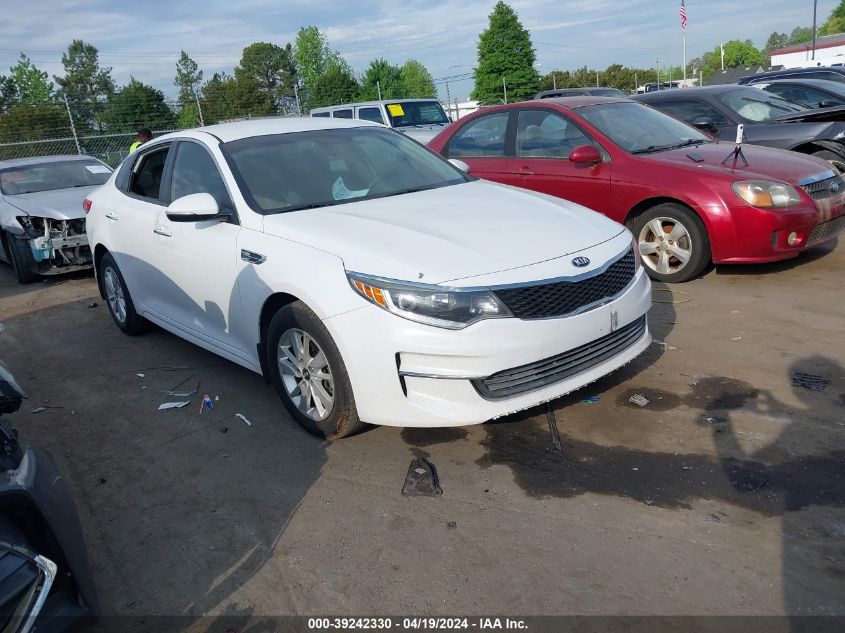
267,301,363,440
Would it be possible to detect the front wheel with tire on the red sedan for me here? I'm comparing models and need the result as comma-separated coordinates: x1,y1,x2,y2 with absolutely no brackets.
628,202,711,283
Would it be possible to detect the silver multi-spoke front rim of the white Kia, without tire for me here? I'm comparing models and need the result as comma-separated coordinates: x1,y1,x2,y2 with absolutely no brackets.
277,328,335,422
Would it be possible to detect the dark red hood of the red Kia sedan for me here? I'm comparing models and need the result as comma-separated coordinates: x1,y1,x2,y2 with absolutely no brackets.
640,143,831,184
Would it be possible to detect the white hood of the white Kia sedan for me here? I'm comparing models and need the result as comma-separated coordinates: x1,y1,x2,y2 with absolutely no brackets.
264,181,625,284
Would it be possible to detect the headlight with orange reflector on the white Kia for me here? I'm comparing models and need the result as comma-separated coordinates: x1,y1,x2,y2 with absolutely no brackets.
348,273,512,330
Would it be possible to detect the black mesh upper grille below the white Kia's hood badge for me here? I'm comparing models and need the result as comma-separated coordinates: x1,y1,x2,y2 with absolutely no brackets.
495,249,636,319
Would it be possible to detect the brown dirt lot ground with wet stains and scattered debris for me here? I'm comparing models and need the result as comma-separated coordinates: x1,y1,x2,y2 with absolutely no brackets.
0,239,845,617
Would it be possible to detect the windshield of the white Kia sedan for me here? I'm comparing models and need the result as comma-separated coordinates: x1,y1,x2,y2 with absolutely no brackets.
224,126,471,213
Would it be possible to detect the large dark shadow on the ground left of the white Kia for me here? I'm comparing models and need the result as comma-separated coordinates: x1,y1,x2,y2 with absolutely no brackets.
0,262,327,631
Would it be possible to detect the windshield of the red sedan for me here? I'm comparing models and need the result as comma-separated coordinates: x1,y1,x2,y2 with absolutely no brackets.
575,103,711,154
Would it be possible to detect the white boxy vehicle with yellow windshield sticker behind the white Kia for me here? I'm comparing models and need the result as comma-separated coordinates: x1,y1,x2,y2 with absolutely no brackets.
309,99,451,145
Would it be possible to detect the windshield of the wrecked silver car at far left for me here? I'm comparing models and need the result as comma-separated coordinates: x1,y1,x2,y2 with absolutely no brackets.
0,160,111,196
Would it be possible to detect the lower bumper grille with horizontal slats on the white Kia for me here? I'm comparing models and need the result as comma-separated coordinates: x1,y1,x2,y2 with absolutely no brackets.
472,315,646,400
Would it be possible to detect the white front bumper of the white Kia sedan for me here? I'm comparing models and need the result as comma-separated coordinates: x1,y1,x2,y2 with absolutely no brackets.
325,270,651,427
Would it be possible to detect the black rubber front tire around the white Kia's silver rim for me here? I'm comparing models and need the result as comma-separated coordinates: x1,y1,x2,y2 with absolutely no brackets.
266,301,364,440
